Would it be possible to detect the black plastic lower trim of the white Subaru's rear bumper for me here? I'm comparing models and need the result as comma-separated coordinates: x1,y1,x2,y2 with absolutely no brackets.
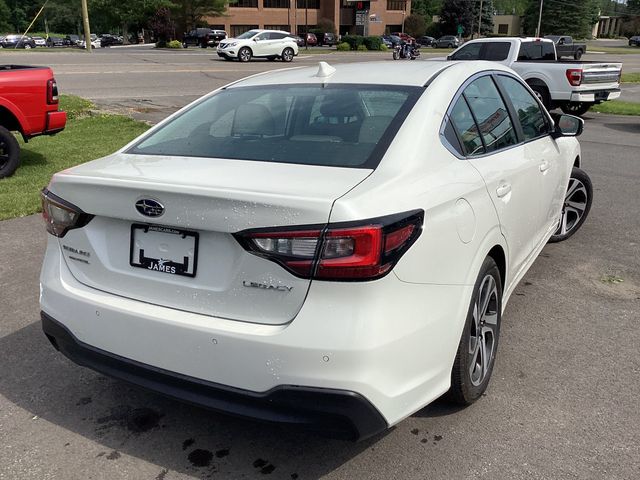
41,312,388,440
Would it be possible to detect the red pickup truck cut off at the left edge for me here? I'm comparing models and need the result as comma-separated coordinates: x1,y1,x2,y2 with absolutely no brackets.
0,65,67,178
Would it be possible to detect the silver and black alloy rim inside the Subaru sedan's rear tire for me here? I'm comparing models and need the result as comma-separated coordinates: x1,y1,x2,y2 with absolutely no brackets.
468,275,498,387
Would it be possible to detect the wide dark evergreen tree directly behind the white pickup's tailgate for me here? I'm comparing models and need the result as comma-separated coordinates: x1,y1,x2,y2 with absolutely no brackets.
524,0,599,38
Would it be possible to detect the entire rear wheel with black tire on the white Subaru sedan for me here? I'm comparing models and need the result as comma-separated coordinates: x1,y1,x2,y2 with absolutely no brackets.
447,257,502,406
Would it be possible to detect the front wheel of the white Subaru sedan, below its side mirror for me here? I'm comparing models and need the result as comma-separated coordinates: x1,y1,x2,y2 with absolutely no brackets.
549,167,593,243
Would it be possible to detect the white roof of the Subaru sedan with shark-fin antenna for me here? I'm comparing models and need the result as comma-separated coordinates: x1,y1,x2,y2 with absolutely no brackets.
230,61,468,88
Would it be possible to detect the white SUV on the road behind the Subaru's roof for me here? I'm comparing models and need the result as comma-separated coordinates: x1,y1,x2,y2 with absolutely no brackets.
218,30,298,62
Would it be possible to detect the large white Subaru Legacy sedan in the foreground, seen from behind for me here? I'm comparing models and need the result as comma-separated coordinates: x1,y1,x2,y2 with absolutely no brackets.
40,62,592,439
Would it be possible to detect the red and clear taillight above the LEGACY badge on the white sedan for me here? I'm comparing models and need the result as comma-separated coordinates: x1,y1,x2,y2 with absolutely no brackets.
235,210,424,281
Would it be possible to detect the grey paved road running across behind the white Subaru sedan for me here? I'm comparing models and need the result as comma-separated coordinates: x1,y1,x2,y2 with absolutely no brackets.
0,47,640,123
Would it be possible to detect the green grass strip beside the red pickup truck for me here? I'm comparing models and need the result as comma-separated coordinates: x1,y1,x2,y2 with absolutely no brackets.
0,95,149,220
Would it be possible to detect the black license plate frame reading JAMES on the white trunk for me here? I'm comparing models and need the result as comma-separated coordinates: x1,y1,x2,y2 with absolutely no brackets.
129,223,200,278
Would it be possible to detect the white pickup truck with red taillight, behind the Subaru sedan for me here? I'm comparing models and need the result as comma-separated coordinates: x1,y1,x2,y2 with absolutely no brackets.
447,38,622,115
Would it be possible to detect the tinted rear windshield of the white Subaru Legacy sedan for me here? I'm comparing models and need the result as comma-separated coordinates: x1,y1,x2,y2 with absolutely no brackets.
128,84,424,168
